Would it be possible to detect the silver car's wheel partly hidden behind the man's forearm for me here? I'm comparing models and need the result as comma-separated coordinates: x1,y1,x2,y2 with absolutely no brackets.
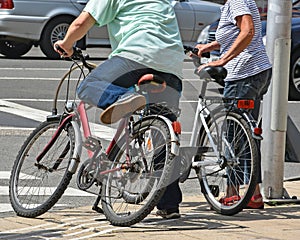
40,16,74,59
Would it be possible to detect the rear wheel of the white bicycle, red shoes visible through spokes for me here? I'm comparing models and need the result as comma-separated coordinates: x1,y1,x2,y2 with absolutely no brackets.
195,111,259,215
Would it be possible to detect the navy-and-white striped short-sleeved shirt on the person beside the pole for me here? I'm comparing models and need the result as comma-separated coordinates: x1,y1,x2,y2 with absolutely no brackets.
216,0,271,81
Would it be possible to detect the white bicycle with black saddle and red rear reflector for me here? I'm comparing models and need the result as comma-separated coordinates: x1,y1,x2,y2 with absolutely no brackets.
180,46,262,215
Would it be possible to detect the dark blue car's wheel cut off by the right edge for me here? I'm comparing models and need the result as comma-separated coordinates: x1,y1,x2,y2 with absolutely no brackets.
289,49,300,100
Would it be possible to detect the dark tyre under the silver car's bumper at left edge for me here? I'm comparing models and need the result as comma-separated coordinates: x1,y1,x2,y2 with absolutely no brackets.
0,40,33,58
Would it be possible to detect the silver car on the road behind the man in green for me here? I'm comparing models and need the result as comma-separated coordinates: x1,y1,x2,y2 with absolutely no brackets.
0,0,220,58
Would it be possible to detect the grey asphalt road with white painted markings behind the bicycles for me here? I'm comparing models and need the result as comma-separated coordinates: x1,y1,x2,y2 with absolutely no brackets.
0,45,300,217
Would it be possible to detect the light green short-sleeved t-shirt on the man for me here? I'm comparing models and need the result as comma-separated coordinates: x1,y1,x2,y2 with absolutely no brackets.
84,0,184,78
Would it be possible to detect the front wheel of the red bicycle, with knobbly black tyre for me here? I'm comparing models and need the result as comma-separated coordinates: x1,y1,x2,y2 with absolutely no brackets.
9,120,74,217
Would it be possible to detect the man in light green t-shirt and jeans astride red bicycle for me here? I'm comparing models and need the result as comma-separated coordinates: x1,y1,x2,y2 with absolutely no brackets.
54,0,184,220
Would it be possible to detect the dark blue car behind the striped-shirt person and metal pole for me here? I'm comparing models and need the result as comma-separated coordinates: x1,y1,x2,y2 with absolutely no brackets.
197,0,300,101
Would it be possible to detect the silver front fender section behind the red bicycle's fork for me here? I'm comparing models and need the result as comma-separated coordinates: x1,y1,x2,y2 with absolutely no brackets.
68,121,82,173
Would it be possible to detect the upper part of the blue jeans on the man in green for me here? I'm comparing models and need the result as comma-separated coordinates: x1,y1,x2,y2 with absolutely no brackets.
77,56,182,109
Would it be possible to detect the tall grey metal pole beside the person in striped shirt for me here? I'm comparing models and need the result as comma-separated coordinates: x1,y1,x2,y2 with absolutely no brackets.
261,0,292,199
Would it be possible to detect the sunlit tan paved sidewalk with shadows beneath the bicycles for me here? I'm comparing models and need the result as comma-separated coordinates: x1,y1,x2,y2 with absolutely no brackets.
0,181,300,240
